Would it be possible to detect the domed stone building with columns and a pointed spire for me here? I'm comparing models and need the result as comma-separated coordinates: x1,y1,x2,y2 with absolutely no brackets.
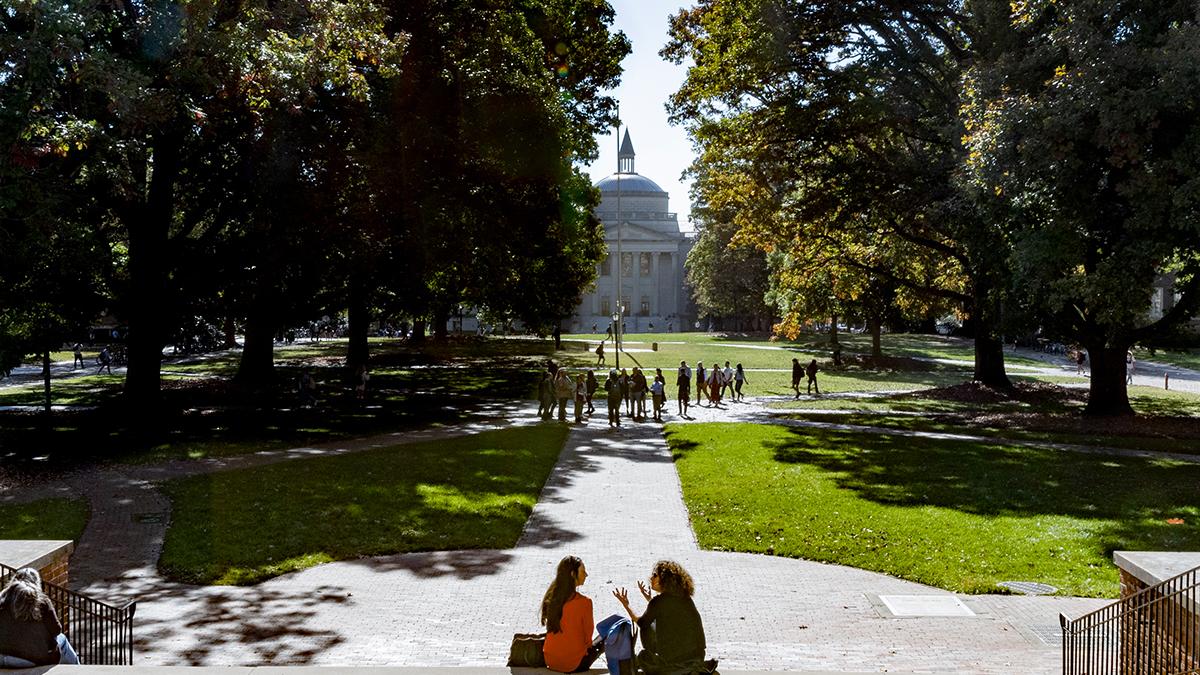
572,130,695,333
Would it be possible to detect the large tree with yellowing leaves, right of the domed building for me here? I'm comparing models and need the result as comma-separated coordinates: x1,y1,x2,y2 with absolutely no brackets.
664,0,1009,386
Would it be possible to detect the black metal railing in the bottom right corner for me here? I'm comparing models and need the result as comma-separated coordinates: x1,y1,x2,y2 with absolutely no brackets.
1058,567,1200,675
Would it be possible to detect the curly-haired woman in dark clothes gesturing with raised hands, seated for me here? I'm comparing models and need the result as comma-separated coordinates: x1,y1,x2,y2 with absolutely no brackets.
612,560,715,675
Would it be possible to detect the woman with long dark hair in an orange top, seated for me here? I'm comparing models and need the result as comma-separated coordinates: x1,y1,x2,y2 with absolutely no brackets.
541,555,604,673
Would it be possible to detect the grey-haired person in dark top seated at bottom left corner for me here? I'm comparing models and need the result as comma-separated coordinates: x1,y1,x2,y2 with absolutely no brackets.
0,567,79,668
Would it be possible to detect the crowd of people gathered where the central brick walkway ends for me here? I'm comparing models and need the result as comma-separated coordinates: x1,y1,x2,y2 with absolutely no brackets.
538,362,750,426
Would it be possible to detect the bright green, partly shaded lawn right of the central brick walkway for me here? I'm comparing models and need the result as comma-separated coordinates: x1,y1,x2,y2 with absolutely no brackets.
667,424,1200,597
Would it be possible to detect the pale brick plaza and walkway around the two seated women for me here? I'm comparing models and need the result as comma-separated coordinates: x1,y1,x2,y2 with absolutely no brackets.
2,393,1123,673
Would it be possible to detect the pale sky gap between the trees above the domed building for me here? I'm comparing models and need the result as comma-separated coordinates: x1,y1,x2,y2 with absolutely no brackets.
584,0,692,231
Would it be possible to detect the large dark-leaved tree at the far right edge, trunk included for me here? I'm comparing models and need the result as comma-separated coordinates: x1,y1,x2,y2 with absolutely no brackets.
964,0,1200,414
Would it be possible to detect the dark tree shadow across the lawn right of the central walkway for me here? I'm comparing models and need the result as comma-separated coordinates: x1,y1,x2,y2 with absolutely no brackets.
768,429,1200,555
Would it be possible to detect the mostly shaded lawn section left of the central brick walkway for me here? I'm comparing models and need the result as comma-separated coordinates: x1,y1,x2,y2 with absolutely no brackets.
158,425,568,585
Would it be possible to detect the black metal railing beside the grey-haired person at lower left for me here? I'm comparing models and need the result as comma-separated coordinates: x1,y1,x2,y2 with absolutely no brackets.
0,557,137,665
